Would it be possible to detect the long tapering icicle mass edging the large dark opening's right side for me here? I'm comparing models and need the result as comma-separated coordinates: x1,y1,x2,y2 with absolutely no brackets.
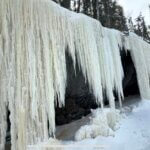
72,15,103,107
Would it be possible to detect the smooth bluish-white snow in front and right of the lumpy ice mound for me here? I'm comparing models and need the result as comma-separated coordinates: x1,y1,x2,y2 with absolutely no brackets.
60,96,150,150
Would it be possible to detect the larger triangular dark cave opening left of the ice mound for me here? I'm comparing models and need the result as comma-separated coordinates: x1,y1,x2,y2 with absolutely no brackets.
55,52,98,125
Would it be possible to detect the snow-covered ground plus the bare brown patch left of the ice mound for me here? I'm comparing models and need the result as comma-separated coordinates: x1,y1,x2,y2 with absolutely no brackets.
29,97,150,150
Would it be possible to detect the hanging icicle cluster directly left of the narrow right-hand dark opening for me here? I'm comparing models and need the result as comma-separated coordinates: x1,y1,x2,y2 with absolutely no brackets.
103,28,124,107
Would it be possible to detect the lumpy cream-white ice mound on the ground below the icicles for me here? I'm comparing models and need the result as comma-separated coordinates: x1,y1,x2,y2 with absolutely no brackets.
75,109,120,141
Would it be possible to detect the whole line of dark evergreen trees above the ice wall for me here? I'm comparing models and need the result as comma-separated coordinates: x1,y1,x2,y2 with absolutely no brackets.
54,0,150,43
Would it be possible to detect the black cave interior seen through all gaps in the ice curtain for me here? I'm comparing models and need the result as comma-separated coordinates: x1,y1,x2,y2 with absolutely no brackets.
55,50,139,126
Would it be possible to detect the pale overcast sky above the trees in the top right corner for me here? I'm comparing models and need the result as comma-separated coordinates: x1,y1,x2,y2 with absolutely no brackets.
117,0,150,25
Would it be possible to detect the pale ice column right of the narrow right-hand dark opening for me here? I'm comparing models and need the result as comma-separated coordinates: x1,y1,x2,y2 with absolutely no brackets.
126,33,150,99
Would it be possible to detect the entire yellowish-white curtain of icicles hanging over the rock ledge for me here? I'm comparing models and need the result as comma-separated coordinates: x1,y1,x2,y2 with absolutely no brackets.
0,0,150,150
